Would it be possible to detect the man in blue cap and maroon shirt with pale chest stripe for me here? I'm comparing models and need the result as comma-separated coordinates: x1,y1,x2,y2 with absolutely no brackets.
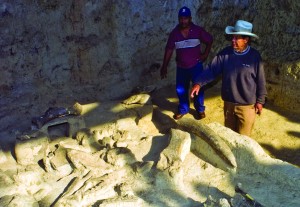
160,7,213,120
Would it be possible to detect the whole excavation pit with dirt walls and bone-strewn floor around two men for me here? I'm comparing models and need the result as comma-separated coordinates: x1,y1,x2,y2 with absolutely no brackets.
0,0,300,207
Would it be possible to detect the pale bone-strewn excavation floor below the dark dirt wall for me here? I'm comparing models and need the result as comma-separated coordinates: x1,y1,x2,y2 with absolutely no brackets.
0,85,300,207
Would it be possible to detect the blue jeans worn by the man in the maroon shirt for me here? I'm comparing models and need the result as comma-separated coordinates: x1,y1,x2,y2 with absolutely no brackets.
176,62,205,114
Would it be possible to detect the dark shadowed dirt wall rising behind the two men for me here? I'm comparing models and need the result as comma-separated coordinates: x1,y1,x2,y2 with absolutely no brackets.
0,0,300,133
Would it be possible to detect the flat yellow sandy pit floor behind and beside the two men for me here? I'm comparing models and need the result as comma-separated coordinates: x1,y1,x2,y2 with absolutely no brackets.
153,84,300,167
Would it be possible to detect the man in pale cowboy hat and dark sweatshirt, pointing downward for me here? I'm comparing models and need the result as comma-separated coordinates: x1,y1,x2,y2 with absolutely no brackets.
190,20,267,136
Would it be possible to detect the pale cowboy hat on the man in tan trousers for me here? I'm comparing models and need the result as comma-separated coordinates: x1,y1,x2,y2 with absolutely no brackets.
225,20,258,38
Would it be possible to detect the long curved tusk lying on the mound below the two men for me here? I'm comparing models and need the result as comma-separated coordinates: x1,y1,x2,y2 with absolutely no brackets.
177,118,236,168
